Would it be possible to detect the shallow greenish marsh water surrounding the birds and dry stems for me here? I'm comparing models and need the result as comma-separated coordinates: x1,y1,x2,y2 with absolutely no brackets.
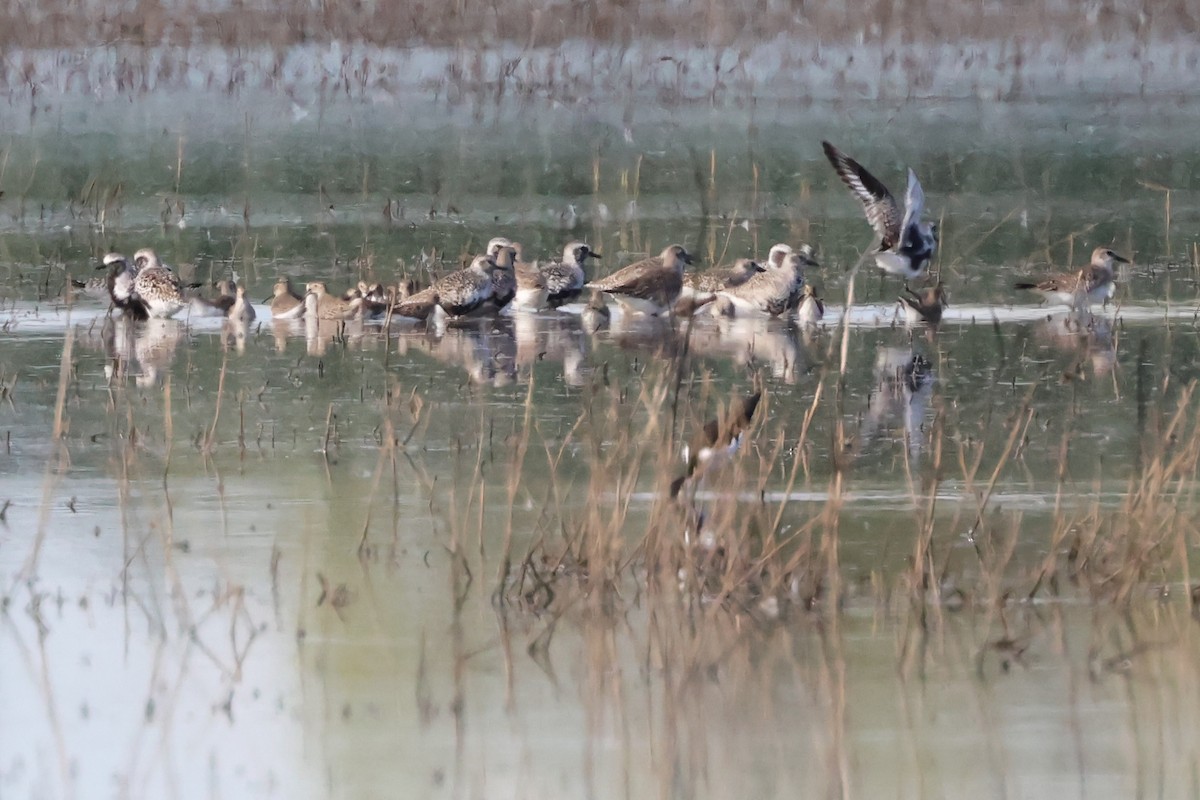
0,76,1200,798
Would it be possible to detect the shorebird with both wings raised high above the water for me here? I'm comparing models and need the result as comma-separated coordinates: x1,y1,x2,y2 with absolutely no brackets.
821,142,937,281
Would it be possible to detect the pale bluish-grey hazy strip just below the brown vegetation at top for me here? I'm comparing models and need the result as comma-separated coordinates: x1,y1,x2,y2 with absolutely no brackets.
0,34,1200,108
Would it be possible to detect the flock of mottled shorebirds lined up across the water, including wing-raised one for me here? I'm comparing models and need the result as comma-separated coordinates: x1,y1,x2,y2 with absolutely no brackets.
73,142,1127,335
